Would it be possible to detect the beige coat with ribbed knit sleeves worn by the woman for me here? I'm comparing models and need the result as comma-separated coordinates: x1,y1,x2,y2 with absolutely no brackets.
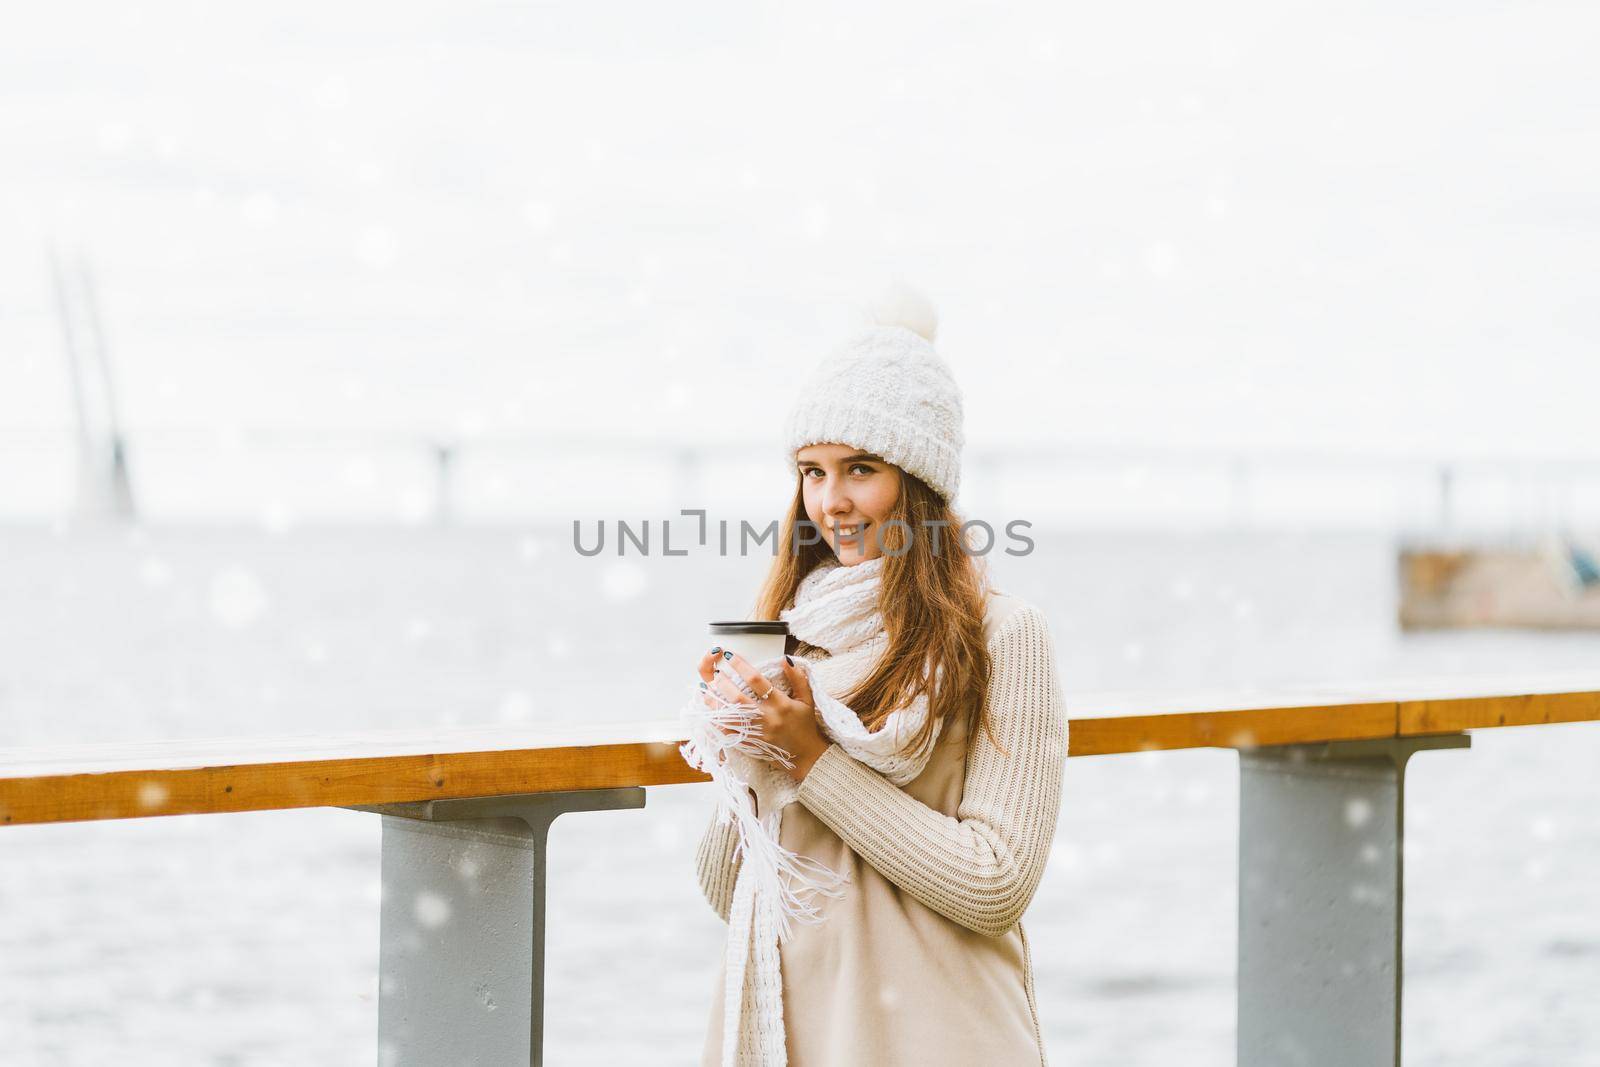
696,592,1067,1067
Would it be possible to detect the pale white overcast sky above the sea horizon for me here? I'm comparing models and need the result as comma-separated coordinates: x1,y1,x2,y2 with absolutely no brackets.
0,0,1600,518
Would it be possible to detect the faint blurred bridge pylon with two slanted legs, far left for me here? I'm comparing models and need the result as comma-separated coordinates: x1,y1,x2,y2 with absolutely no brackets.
50,246,136,520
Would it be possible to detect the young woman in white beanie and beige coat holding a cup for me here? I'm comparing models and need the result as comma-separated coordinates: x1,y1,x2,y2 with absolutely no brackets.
696,294,1067,1067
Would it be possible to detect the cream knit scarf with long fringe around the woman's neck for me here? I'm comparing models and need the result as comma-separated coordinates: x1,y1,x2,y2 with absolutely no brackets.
680,555,938,1067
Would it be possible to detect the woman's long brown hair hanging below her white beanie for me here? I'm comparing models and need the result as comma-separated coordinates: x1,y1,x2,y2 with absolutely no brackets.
754,464,1000,752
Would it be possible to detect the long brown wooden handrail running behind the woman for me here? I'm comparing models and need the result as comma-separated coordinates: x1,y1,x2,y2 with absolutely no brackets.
0,672,1600,825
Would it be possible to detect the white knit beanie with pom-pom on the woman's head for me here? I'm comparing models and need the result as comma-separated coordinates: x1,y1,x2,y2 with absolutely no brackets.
784,290,965,504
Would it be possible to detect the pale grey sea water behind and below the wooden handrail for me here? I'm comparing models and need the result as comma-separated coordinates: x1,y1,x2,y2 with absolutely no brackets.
0,526,1600,1067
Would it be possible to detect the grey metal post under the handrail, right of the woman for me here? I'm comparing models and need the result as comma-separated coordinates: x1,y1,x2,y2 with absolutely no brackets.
1237,734,1472,1067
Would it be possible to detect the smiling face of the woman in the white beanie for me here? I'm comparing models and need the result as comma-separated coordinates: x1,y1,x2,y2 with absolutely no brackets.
795,445,899,566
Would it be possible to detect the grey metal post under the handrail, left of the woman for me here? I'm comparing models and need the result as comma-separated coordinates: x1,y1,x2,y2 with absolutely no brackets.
355,785,645,1067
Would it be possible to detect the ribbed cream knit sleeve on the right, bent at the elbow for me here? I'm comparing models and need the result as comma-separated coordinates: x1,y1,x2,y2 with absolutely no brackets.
798,605,1067,937
